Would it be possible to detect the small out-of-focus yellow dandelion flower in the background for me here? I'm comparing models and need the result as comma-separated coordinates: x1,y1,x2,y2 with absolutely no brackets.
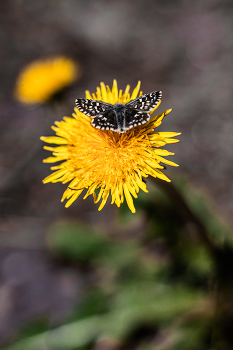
14,56,78,105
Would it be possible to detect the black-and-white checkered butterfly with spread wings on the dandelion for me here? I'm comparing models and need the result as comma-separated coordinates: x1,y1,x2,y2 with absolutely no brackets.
75,91,162,133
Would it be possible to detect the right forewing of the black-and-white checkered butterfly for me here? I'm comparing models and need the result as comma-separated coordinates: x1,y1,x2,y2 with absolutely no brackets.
125,91,162,113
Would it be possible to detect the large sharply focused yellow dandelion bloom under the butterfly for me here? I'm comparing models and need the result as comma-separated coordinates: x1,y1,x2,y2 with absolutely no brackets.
41,80,180,213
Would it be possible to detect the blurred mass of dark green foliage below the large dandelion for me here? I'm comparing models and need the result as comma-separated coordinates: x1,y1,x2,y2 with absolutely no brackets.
5,179,232,350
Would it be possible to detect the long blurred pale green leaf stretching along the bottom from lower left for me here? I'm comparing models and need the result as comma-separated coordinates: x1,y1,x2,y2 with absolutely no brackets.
4,283,210,350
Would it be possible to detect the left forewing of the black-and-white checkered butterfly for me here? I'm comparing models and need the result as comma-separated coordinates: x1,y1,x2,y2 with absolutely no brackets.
75,98,112,117
